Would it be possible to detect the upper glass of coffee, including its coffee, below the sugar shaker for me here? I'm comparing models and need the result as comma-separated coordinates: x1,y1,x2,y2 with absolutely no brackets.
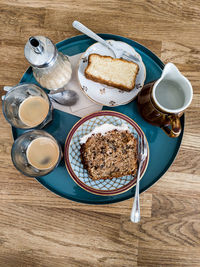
3,84,52,129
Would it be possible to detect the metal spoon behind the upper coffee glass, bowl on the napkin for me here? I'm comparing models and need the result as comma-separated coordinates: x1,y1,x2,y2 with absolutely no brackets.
1,86,78,106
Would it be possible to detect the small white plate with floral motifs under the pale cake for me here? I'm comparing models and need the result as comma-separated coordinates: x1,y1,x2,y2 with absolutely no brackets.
78,40,146,107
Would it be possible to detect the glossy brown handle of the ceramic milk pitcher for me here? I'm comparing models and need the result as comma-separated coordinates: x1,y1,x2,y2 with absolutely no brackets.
160,116,182,137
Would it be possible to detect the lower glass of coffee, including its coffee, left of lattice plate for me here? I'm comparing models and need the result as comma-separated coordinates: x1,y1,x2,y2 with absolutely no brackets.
11,130,62,177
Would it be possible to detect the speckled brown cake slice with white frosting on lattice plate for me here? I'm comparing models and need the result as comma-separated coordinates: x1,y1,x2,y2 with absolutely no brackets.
80,124,137,180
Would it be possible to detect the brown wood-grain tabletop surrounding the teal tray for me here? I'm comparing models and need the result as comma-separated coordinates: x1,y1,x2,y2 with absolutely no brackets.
0,0,200,267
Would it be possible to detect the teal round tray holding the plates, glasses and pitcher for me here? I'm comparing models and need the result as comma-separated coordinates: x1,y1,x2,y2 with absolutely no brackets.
12,34,184,204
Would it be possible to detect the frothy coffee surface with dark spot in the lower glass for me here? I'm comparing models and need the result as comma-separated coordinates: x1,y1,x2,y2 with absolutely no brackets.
26,137,59,170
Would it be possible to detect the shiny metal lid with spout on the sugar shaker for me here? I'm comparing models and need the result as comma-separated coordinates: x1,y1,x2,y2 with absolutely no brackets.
24,36,58,68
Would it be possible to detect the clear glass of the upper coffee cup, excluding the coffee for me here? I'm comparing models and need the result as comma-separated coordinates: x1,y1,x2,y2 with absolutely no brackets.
2,83,53,129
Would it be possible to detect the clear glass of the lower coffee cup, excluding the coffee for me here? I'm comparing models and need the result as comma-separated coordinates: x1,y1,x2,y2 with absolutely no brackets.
11,130,63,177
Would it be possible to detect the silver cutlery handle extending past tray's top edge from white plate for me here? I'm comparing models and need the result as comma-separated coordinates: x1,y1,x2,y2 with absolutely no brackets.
72,20,112,49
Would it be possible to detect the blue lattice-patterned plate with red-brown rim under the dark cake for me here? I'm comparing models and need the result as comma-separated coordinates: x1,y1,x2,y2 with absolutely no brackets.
64,111,149,196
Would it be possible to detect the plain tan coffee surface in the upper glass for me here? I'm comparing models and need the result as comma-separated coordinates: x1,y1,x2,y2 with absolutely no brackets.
19,96,49,127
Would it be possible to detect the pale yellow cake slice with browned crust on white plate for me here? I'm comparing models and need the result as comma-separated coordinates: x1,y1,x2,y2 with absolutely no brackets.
85,54,139,91
